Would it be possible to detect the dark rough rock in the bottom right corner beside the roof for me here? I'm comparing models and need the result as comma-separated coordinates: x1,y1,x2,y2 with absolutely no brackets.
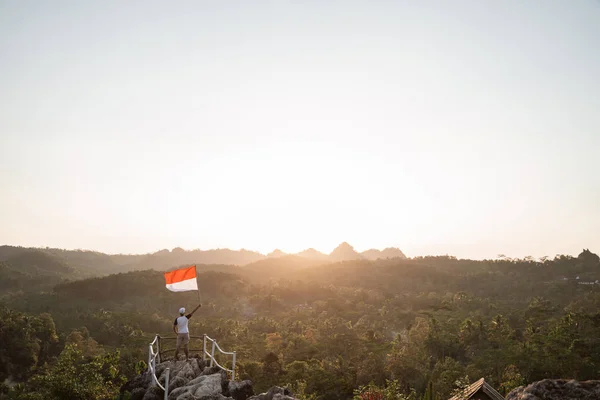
506,379,600,400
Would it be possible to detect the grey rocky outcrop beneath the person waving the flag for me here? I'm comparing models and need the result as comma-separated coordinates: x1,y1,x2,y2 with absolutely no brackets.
121,358,295,400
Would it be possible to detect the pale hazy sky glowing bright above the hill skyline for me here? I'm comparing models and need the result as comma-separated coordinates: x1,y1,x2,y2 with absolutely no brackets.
0,0,600,259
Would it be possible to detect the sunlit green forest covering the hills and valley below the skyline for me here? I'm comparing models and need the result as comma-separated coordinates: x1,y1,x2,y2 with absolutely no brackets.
0,246,600,400
